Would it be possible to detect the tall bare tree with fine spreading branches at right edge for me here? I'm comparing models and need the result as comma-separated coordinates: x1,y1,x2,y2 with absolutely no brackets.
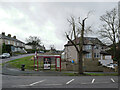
99,8,120,57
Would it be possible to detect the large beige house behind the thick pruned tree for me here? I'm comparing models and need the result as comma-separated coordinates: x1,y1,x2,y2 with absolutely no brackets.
64,37,106,63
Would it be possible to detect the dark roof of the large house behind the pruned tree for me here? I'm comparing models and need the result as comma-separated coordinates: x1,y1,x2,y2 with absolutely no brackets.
65,37,105,46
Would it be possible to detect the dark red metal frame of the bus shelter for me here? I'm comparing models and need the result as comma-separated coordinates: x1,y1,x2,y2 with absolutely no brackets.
34,54,61,72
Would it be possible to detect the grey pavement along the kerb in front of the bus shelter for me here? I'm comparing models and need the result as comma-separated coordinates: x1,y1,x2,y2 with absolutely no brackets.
2,66,67,76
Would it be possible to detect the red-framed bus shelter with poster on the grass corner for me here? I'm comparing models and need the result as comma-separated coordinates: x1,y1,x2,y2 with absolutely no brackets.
34,54,61,72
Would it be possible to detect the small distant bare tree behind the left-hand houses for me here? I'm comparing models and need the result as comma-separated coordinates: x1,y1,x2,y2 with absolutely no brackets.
26,36,41,49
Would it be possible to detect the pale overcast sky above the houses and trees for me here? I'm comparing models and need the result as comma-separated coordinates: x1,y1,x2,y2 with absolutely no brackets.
0,2,118,50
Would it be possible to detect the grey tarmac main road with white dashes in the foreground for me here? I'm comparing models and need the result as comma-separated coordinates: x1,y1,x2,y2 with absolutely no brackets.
2,75,118,88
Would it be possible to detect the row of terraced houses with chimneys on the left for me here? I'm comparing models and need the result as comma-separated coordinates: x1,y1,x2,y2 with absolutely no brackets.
0,32,27,54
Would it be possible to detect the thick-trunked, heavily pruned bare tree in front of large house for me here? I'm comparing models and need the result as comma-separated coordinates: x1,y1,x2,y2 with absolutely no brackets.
66,13,90,74
